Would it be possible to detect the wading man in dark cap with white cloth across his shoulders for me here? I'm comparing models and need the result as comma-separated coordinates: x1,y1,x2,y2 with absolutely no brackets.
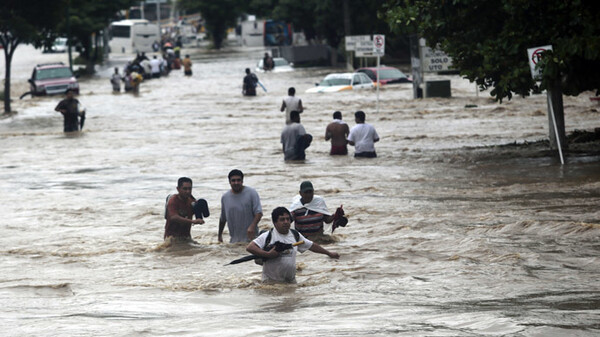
290,181,333,238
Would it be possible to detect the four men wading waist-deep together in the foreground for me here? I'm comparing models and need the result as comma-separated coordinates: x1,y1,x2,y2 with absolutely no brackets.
164,169,348,283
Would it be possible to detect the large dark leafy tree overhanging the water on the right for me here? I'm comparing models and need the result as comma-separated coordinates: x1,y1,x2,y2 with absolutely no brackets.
380,0,600,148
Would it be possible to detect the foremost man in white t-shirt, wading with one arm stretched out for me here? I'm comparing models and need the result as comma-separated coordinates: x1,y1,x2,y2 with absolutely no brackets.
246,207,340,283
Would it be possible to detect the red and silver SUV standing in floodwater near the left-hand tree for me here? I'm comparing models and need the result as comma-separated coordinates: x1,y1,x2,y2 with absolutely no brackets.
28,62,79,96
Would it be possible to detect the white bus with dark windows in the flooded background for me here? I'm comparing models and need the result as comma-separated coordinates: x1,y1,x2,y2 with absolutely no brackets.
109,19,160,54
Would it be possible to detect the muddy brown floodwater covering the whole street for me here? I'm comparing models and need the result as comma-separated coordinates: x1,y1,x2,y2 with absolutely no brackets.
0,46,600,336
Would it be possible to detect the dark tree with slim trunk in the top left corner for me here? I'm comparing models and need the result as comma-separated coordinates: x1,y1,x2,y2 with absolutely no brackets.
0,0,63,113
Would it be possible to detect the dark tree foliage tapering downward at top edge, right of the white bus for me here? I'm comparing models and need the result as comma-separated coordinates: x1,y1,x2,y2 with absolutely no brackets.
179,0,246,49
